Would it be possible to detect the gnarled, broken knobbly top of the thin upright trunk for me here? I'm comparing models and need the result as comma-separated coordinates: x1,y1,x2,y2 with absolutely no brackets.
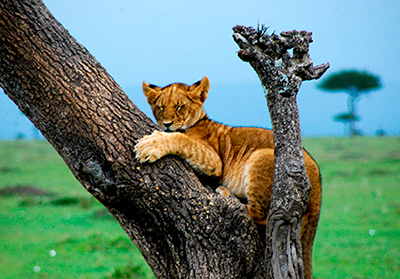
233,25,329,96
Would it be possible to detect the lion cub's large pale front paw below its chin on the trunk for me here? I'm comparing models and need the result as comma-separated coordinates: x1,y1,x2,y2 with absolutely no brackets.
135,131,169,163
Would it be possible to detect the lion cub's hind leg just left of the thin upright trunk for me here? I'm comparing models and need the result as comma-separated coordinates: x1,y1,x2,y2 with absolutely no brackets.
245,148,274,225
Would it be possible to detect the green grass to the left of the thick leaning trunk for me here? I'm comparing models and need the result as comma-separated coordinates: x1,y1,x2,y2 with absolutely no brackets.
0,141,152,279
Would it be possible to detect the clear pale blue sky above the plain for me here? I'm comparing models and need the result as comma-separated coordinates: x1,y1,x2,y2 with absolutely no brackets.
0,0,400,139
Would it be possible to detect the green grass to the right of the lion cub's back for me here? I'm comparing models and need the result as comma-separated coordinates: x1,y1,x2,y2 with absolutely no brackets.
304,137,400,278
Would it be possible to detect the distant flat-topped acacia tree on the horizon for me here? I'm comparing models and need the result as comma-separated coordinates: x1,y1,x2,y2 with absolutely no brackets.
317,70,382,136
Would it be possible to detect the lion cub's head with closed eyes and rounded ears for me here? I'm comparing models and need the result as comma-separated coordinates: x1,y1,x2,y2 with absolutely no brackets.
143,77,210,132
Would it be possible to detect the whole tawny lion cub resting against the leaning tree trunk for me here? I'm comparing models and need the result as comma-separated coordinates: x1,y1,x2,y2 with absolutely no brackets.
135,77,321,278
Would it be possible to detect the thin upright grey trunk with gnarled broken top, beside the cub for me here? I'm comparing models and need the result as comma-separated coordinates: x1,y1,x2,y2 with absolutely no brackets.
233,26,329,278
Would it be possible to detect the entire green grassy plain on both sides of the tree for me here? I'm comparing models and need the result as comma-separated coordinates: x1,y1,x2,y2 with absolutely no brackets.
0,137,400,279
